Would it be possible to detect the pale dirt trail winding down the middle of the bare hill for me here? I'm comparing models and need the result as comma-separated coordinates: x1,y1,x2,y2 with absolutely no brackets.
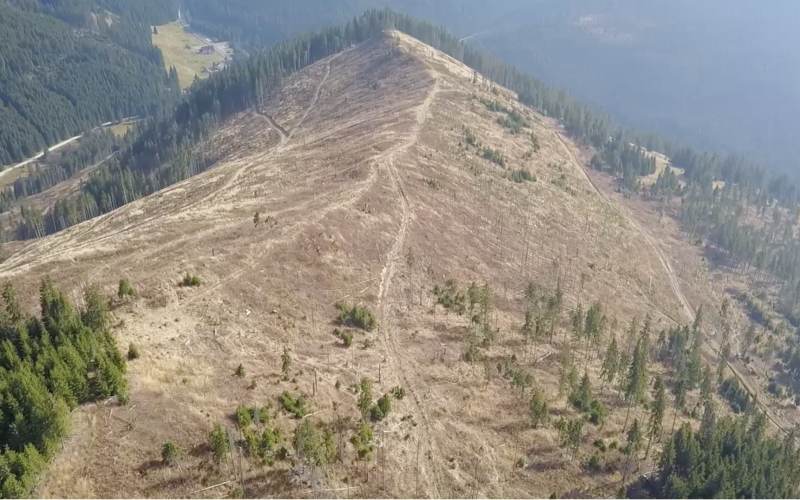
378,77,442,498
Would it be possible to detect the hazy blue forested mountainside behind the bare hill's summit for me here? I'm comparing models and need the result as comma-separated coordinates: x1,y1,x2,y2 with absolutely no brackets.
182,0,800,171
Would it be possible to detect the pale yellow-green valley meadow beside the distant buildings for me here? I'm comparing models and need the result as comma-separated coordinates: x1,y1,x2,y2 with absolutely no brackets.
153,21,222,89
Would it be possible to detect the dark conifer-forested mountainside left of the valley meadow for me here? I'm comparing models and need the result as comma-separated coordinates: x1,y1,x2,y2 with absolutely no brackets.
0,0,179,165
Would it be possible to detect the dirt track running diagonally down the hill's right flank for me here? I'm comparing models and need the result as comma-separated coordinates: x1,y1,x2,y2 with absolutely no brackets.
556,133,789,440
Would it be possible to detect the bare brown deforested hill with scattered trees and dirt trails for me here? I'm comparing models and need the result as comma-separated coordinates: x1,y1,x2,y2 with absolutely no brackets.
0,32,708,497
